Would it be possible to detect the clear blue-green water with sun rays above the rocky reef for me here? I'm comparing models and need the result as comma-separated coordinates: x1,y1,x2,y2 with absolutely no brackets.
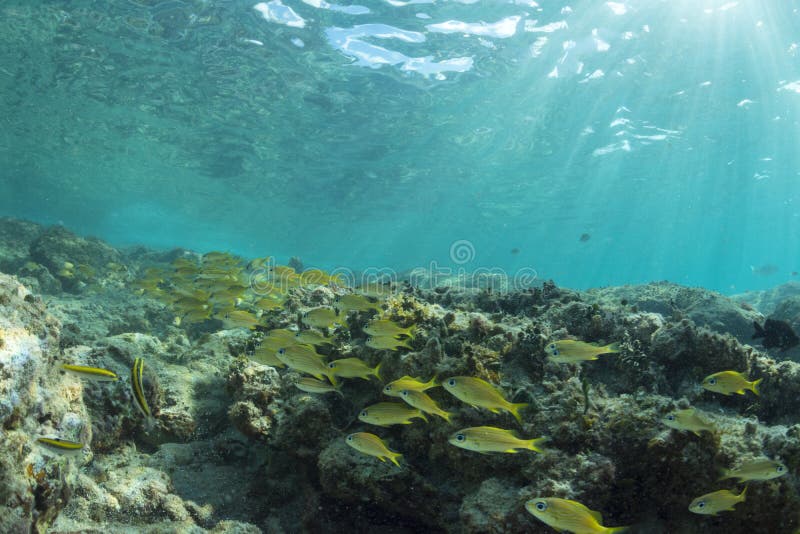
0,0,800,292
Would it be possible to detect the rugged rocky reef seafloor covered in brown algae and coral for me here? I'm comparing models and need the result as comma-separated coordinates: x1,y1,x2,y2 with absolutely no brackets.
0,219,800,534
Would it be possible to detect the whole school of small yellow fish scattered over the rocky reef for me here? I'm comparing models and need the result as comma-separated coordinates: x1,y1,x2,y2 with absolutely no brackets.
38,252,787,534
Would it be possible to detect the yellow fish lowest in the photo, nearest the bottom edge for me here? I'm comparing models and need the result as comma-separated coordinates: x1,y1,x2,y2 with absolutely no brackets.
525,497,628,534
